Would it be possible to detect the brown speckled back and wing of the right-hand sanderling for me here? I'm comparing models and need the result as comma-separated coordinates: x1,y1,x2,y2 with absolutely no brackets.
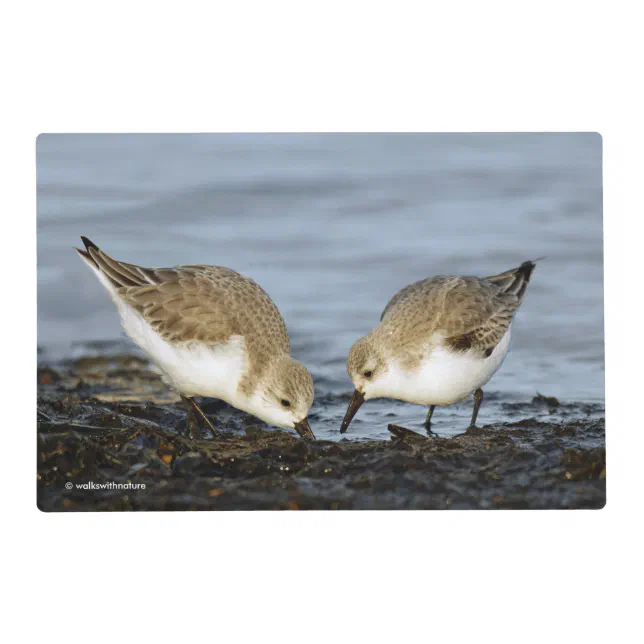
381,262,534,361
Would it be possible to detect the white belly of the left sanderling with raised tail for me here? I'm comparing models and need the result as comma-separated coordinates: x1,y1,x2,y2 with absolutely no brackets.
113,297,248,400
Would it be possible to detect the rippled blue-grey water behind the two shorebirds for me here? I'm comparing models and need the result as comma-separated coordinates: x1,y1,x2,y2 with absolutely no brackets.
37,134,604,438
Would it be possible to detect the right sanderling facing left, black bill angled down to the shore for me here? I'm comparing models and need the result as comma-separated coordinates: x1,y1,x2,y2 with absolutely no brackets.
340,260,538,434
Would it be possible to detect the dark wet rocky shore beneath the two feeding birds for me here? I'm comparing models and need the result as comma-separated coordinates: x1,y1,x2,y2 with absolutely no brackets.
38,354,606,512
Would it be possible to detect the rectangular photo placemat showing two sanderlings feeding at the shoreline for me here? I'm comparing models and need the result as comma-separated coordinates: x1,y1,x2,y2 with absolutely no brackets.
36,132,606,512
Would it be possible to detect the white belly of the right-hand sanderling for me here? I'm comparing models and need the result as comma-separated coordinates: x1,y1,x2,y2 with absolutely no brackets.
380,328,510,405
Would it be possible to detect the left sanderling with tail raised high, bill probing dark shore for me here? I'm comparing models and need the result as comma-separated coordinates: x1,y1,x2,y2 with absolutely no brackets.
76,237,315,438
